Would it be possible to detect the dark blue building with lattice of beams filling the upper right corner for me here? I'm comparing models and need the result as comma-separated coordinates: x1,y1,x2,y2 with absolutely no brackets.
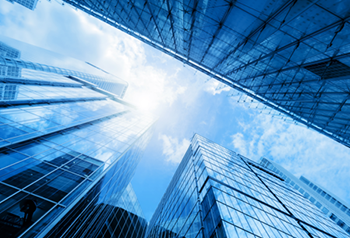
63,0,350,146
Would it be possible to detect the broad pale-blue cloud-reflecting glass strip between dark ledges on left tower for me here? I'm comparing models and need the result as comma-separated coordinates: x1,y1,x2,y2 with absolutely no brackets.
0,100,126,146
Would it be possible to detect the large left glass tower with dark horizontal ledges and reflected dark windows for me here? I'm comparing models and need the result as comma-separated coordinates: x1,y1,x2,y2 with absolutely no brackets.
0,36,154,238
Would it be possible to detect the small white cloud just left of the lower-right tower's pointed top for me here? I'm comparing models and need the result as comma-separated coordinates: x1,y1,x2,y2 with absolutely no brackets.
158,135,191,164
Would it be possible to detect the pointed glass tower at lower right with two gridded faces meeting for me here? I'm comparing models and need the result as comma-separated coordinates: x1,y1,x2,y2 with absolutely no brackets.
146,135,350,238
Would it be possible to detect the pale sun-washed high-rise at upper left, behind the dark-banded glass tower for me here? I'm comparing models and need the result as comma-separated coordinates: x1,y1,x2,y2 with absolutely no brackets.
0,35,128,98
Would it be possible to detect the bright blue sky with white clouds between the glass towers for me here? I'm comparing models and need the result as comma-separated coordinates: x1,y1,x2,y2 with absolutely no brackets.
0,0,350,220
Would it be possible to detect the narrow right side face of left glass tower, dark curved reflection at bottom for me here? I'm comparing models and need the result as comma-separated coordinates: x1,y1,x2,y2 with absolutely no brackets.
38,127,151,238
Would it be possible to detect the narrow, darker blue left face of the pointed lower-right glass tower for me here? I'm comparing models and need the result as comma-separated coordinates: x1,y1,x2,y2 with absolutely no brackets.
146,149,202,237
